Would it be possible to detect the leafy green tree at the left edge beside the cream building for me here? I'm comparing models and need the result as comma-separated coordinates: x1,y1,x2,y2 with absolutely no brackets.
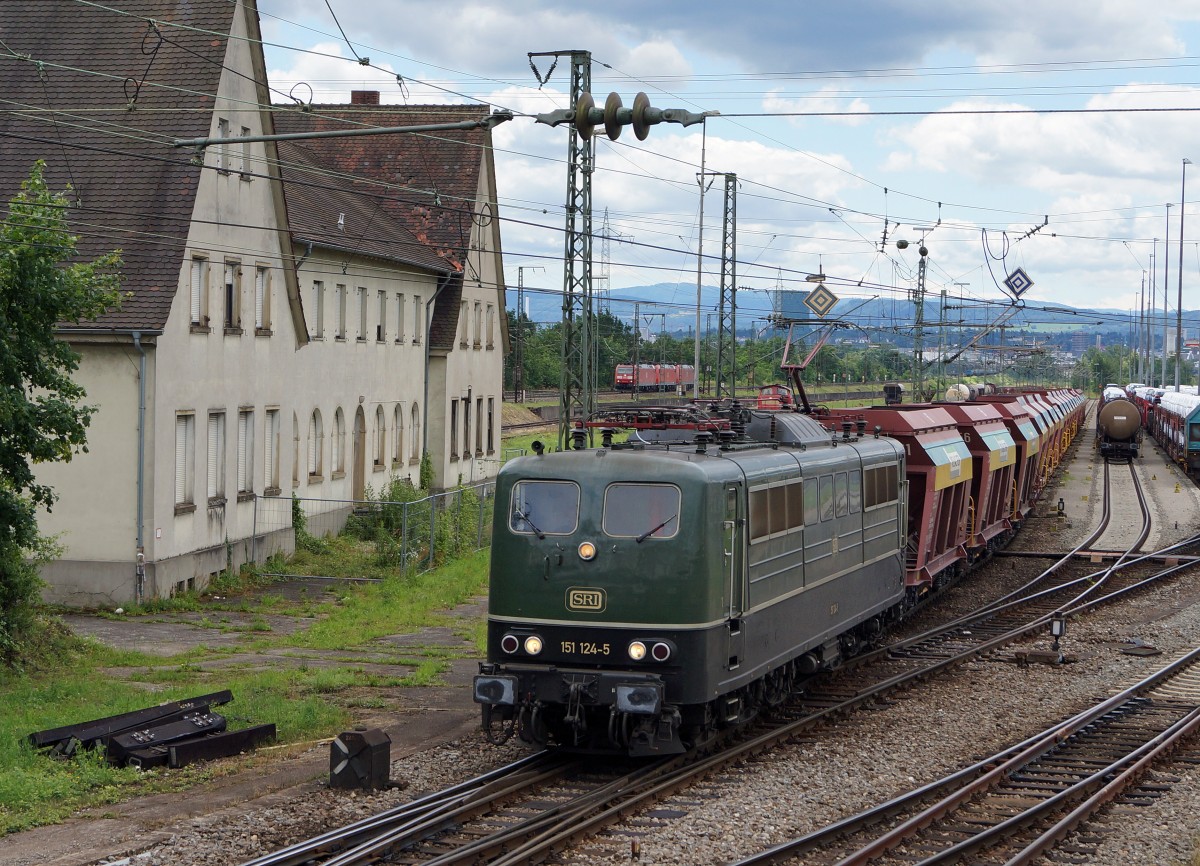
0,161,121,666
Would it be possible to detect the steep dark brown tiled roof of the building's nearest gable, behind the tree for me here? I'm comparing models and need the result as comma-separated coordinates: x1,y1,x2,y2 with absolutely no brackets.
0,0,234,329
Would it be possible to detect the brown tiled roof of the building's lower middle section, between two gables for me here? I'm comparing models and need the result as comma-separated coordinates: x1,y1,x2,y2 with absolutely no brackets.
278,142,454,273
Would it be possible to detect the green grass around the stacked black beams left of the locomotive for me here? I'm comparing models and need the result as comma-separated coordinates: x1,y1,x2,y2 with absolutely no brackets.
0,536,488,835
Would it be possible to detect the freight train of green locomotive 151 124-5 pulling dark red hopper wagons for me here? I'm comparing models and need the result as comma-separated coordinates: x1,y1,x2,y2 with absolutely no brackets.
474,391,1084,756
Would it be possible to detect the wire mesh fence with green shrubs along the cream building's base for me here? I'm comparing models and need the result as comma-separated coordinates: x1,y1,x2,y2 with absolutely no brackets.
253,481,496,573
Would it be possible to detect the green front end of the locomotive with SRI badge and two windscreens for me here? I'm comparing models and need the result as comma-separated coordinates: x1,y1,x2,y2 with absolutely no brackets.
474,449,737,754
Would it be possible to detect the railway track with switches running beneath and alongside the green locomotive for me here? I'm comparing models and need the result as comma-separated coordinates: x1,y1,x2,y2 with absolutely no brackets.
234,427,1200,866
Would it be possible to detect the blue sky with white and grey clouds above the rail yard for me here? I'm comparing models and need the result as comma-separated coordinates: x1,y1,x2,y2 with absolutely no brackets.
259,0,1200,326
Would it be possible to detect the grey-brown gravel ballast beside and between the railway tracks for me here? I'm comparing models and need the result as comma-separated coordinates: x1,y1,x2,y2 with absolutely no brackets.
14,412,1200,866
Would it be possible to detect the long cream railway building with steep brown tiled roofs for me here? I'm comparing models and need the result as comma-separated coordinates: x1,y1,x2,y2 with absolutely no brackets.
0,0,508,605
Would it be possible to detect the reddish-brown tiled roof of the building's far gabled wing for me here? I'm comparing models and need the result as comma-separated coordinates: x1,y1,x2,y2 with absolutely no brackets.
275,104,492,348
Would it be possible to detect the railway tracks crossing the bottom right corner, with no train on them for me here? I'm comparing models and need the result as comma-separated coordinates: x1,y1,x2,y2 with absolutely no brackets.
737,649,1200,866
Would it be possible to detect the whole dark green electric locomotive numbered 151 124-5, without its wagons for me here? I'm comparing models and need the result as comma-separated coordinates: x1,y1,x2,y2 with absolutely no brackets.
474,410,907,756
